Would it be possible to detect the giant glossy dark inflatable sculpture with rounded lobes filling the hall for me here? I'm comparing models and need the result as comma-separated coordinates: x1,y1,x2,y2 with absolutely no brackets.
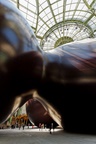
0,0,96,134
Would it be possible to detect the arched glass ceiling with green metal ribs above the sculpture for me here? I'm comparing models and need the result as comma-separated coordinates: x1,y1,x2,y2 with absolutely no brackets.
10,0,96,50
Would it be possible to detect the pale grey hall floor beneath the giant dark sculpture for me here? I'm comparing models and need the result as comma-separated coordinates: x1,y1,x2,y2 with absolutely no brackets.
0,127,96,144
